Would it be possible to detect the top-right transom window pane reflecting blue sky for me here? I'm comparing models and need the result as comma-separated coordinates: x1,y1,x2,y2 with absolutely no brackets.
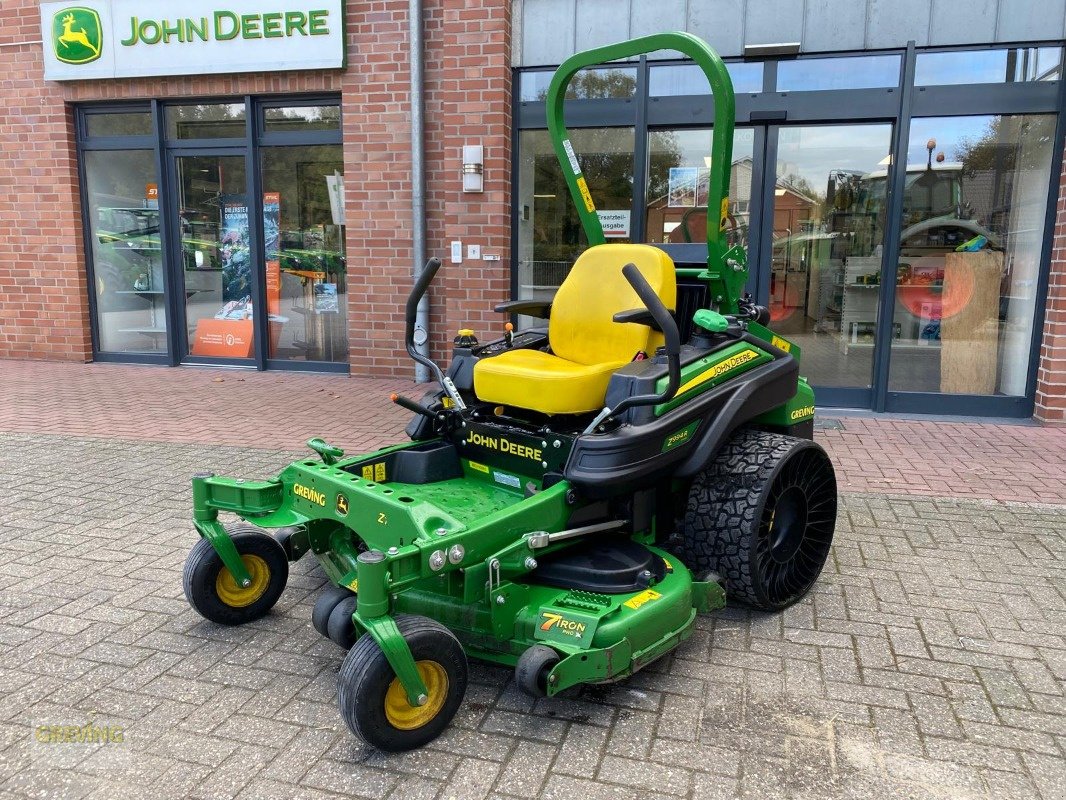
915,47,1063,86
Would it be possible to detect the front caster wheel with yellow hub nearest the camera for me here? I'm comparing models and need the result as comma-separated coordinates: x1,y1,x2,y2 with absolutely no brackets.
337,615,467,753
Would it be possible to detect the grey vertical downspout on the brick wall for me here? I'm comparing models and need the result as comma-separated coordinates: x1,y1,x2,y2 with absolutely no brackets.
407,0,430,383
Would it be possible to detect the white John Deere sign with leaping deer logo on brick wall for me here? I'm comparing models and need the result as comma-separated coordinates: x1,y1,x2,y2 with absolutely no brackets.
41,0,344,80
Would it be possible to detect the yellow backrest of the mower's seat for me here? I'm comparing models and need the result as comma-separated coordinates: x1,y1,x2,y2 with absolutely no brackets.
548,244,677,365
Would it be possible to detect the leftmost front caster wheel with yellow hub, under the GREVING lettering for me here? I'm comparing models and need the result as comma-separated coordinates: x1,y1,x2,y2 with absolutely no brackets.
181,525,289,625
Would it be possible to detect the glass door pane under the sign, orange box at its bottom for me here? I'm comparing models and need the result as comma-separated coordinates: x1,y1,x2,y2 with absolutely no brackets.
172,154,255,363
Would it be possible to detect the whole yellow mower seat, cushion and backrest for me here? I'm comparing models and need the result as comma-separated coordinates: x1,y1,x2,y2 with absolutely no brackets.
473,244,677,414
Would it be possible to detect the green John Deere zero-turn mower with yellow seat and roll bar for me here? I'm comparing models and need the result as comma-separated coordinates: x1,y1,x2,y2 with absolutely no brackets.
184,33,837,751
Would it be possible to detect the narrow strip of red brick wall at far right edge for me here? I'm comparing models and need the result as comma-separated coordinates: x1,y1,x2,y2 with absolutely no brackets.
1033,151,1066,425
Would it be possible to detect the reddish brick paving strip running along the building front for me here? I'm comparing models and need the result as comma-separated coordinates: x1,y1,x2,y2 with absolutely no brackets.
0,361,1066,503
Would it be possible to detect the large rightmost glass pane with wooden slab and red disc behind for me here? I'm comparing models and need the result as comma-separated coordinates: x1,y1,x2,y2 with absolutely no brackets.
889,115,1055,396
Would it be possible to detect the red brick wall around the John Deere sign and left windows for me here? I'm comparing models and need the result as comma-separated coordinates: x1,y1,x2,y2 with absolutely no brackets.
0,0,511,375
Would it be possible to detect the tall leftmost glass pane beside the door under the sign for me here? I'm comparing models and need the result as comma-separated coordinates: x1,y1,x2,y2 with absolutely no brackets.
84,150,166,353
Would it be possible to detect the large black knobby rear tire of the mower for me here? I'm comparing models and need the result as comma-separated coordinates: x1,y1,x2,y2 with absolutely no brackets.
672,430,837,611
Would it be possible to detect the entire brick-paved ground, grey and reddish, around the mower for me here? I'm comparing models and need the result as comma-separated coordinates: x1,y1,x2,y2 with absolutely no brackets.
0,362,1066,800
